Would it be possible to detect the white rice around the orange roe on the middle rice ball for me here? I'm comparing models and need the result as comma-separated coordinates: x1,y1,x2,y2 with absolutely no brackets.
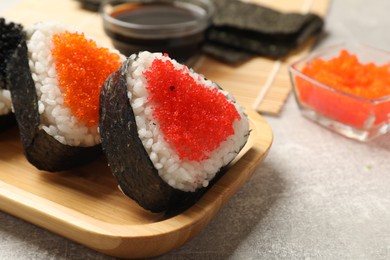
26,21,123,147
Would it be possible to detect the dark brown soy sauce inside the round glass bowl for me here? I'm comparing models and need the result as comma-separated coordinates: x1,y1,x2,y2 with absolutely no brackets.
105,3,209,63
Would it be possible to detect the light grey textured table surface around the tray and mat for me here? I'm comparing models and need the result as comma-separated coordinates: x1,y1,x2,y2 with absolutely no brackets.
0,0,390,259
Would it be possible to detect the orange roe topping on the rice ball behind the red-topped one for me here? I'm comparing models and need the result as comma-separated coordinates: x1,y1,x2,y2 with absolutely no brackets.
51,32,121,126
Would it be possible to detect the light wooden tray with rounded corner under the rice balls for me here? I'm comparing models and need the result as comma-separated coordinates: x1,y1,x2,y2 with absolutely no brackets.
0,110,272,258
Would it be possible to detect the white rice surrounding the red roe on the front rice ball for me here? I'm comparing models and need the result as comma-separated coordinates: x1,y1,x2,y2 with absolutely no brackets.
127,52,249,191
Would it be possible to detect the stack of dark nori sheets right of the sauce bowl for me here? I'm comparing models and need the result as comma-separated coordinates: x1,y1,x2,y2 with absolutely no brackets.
203,0,324,63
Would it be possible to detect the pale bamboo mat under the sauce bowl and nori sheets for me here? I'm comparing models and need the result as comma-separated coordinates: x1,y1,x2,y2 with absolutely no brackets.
0,0,330,115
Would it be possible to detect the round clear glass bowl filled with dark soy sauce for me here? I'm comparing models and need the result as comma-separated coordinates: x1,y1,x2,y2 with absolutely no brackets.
100,0,214,64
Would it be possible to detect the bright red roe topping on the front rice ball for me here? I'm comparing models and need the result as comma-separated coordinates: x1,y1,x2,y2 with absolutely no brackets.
144,59,240,161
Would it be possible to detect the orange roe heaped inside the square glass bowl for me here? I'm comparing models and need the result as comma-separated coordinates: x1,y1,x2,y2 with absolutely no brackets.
295,49,390,128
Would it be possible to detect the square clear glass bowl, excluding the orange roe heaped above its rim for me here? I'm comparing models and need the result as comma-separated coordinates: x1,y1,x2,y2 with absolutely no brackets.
289,43,390,141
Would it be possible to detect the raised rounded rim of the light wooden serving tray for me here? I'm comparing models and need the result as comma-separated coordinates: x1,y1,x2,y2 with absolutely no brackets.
0,110,272,258
